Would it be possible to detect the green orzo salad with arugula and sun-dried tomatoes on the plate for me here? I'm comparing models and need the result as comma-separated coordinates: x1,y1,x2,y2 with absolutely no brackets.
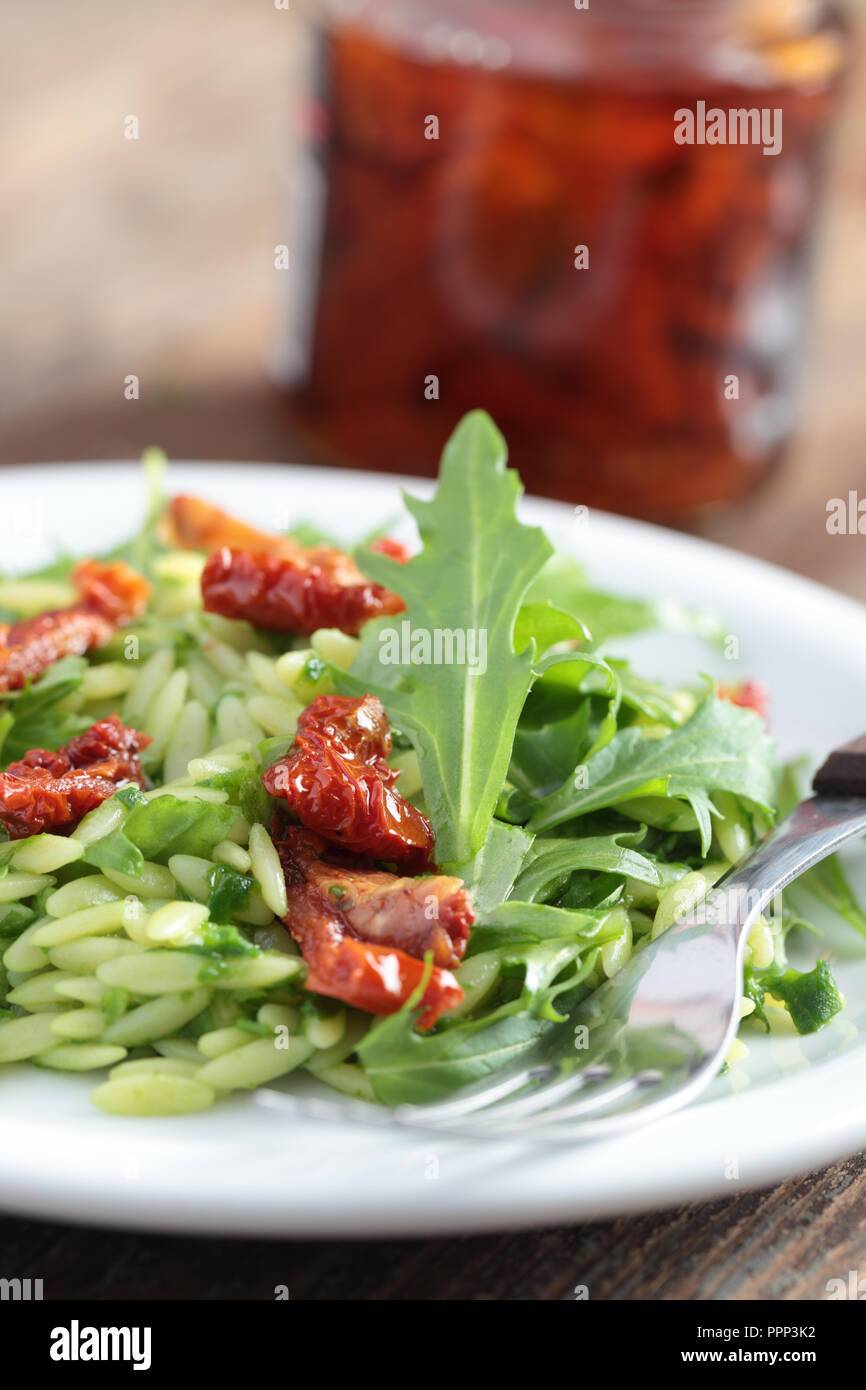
0,411,866,1116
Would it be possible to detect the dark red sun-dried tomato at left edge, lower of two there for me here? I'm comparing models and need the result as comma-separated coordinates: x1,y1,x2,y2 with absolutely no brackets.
0,714,150,840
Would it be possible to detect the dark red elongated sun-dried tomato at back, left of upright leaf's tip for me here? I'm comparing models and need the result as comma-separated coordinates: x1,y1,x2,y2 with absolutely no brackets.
202,549,405,635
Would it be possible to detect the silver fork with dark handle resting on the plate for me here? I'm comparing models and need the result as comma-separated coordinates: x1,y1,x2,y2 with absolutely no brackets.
253,735,866,1143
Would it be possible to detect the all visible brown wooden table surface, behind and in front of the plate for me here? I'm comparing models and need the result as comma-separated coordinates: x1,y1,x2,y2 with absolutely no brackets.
0,0,866,1300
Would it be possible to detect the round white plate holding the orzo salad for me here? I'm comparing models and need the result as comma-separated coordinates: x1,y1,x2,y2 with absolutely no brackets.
0,464,866,1236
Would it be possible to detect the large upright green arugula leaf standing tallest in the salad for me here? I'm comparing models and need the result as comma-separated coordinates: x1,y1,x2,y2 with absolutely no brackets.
335,411,550,866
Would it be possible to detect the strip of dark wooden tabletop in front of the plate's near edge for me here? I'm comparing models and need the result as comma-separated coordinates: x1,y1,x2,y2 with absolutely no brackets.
0,1154,866,1300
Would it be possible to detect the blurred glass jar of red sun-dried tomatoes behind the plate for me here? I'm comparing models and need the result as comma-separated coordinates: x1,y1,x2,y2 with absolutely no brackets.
277,0,848,517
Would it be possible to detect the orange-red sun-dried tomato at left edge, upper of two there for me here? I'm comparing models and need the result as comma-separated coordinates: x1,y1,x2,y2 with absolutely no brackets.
0,560,150,691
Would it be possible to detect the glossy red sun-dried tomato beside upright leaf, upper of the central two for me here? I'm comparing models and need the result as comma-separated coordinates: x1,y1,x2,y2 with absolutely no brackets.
263,695,434,873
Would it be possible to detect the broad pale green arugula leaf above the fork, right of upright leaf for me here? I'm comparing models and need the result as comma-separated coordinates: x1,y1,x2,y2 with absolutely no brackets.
527,691,774,855
